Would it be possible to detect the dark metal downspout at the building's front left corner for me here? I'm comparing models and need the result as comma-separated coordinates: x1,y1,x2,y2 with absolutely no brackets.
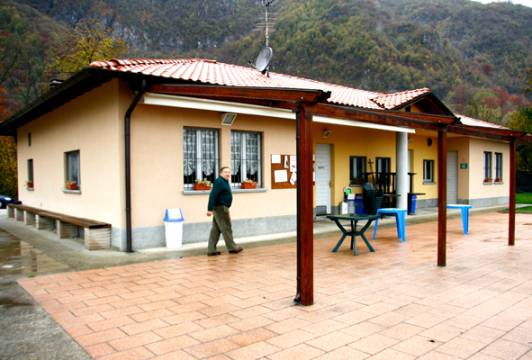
124,80,147,253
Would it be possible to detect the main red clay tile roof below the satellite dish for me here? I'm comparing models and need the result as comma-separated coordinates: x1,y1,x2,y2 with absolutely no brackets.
90,59,430,109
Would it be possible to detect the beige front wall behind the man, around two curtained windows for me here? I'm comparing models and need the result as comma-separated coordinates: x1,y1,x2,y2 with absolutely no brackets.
128,105,296,227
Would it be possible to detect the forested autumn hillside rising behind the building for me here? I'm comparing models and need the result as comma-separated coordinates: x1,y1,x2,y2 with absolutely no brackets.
0,0,532,115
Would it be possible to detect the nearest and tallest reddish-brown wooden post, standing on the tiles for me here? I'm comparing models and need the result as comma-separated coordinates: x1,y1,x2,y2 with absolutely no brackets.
294,104,314,305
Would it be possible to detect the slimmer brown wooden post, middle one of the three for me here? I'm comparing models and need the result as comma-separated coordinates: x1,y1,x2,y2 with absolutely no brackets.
438,128,447,266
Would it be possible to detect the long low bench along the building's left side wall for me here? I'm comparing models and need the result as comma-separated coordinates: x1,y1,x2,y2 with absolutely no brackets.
7,204,111,250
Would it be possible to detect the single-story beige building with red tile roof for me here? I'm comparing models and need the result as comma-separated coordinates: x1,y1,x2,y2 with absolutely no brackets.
0,59,524,250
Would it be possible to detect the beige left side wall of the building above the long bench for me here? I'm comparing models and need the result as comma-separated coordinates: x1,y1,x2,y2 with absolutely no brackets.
17,81,123,227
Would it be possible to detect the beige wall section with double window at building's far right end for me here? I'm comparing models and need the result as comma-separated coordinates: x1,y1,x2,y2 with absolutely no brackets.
469,138,510,199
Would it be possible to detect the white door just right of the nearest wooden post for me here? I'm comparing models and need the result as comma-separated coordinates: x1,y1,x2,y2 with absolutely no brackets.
316,144,331,215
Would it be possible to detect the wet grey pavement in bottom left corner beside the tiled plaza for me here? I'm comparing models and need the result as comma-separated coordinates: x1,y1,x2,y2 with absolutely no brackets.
0,229,90,360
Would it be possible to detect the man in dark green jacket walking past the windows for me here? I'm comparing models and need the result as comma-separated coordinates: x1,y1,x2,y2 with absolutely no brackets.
207,166,242,256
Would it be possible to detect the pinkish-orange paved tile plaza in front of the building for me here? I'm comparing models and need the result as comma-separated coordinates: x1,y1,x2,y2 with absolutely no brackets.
19,212,532,360
